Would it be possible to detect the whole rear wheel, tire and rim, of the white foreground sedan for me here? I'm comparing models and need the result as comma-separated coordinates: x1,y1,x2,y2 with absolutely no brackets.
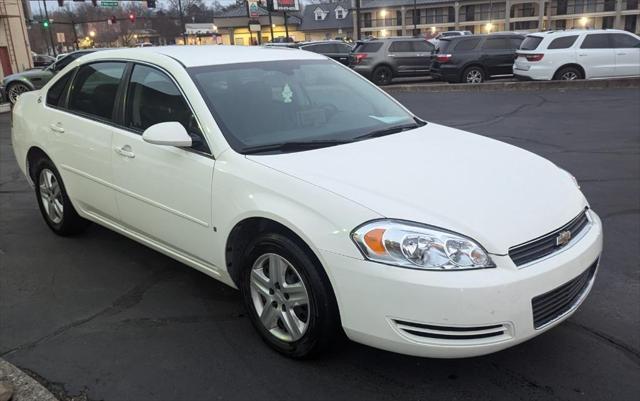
34,158,89,236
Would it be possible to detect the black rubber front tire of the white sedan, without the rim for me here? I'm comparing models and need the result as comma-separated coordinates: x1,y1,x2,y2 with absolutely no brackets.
240,233,340,358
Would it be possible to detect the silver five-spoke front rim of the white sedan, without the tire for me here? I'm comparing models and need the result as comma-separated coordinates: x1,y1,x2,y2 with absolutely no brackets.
250,253,309,342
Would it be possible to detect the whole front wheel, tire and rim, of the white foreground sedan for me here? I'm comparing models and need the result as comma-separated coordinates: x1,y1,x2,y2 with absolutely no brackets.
240,233,339,358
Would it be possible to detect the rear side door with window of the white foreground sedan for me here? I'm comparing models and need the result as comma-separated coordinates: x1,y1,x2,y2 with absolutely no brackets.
47,61,126,220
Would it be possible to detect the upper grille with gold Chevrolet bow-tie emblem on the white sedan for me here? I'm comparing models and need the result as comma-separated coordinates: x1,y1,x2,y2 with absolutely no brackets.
509,209,589,266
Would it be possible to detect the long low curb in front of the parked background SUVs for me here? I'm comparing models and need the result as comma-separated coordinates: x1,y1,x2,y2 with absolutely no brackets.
382,78,640,93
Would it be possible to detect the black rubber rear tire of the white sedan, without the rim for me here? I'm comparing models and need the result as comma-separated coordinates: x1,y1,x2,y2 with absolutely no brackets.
33,157,89,236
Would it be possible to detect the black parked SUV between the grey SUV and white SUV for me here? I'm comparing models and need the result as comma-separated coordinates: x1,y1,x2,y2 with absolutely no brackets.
431,33,524,83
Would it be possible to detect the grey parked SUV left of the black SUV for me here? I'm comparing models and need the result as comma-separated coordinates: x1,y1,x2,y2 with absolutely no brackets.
350,37,435,85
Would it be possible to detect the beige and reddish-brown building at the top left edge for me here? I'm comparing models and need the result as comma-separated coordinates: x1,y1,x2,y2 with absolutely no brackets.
0,0,33,79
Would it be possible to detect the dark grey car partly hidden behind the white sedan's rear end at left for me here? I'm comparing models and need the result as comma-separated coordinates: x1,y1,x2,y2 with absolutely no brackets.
0,49,96,104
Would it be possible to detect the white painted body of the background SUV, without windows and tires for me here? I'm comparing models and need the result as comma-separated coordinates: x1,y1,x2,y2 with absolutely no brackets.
513,29,640,80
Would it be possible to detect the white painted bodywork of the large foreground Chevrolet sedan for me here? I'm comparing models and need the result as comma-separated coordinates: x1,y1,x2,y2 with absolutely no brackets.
12,46,602,358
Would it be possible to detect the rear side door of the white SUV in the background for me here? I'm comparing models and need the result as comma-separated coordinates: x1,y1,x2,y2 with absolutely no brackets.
578,33,616,78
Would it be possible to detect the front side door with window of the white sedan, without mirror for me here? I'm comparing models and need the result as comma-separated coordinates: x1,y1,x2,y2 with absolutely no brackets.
113,65,214,262
